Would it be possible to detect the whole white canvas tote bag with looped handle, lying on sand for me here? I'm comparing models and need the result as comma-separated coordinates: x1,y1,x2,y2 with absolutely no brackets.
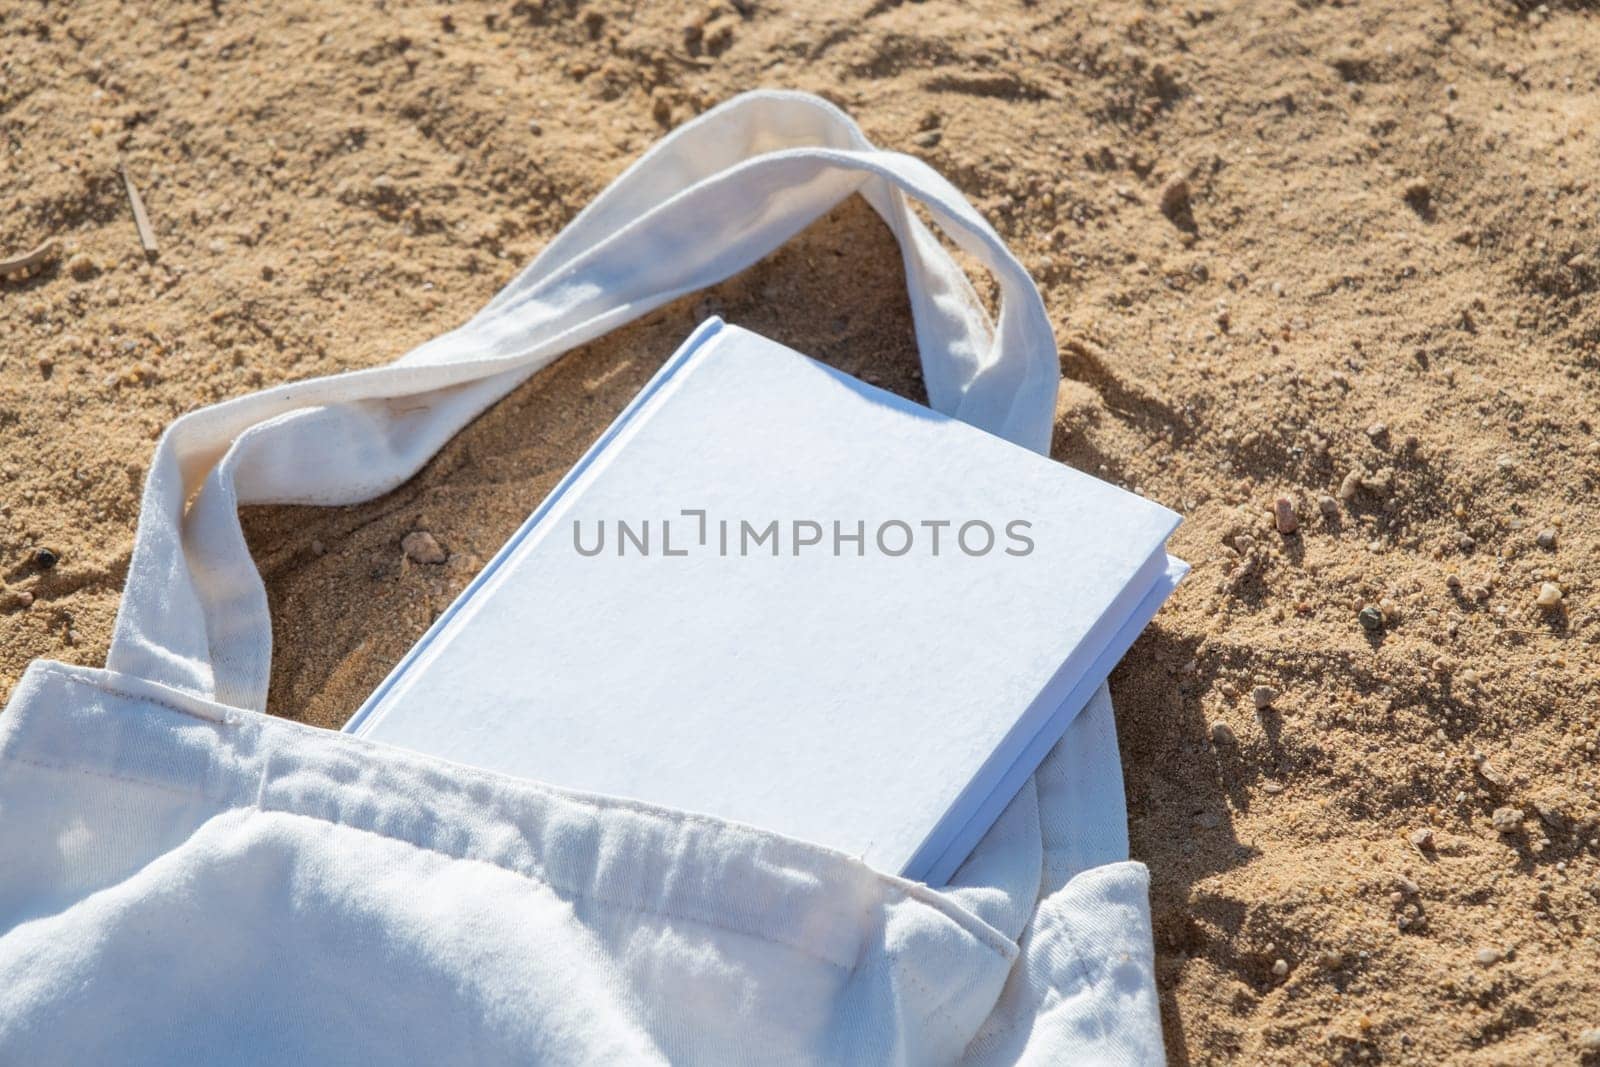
0,93,1162,1064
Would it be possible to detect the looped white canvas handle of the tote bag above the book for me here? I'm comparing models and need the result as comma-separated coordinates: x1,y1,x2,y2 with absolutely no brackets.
106,93,1059,710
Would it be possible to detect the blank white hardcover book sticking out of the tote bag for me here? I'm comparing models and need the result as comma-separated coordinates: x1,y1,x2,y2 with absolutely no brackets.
346,320,1187,885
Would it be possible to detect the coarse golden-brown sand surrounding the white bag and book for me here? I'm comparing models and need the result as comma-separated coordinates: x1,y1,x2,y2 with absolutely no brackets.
0,0,1600,1064
